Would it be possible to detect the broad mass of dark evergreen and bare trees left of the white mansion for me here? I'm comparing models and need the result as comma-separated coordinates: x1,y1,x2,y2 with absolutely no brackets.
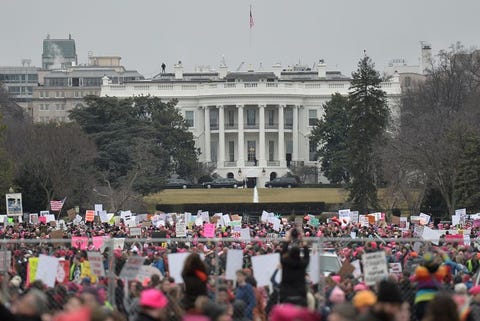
0,88,201,211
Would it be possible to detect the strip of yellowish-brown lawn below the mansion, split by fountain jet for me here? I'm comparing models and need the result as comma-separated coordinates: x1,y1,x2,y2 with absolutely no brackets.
145,188,348,207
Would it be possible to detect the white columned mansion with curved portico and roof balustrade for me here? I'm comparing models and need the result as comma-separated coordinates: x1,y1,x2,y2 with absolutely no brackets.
101,62,400,187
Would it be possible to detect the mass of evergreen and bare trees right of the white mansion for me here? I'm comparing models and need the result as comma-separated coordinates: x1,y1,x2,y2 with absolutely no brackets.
311,45,480,216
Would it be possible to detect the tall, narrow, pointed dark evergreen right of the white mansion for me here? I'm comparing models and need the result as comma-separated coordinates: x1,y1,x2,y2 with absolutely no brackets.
347,55,389,212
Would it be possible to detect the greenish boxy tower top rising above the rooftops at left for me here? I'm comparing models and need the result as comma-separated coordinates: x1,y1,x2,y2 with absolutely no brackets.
42,35,78,69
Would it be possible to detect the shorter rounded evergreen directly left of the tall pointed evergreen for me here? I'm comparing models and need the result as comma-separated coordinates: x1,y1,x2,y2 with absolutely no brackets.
311,93,350,184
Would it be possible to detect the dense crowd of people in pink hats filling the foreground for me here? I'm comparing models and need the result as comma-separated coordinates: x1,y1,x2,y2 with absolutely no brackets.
0,210,480,321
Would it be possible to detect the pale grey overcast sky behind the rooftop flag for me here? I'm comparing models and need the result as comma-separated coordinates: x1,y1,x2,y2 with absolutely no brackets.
0,0,480,77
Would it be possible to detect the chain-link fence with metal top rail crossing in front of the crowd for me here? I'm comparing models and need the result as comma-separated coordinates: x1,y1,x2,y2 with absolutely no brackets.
0,235,464,320
